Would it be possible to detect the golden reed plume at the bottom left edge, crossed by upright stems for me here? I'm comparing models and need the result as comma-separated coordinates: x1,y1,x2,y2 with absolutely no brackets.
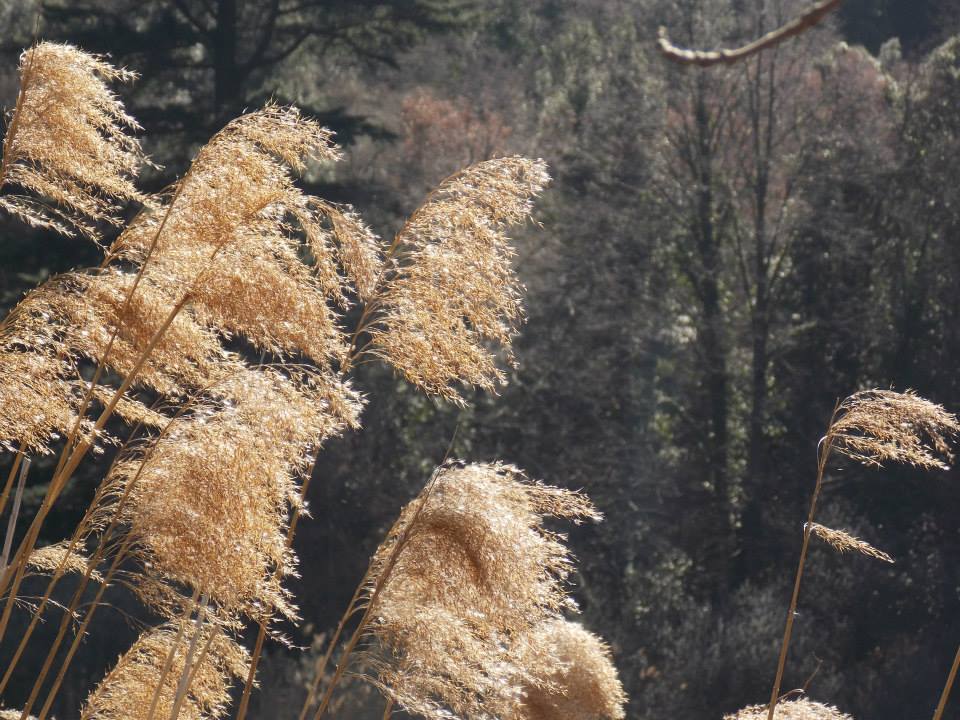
81,623,247,720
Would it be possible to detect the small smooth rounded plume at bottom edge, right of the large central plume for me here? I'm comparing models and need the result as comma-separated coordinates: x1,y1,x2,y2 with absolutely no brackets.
519,619,627,720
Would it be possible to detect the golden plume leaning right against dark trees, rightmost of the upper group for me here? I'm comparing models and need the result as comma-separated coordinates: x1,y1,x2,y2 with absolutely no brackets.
370,157,549,403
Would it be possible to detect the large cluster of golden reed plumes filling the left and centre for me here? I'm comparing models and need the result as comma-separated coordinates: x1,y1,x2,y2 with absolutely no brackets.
0,43,624,720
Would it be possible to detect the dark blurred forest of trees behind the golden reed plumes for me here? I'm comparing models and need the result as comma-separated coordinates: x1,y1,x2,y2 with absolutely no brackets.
0,0,960,720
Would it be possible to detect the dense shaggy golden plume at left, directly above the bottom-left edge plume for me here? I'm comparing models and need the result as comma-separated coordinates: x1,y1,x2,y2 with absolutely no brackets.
108,370,358,618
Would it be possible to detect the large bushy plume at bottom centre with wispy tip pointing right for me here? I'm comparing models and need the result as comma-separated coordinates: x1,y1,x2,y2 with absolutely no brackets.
367,464,599,719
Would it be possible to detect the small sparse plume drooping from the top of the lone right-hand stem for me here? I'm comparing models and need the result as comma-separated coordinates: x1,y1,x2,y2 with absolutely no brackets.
827,390,960,470
